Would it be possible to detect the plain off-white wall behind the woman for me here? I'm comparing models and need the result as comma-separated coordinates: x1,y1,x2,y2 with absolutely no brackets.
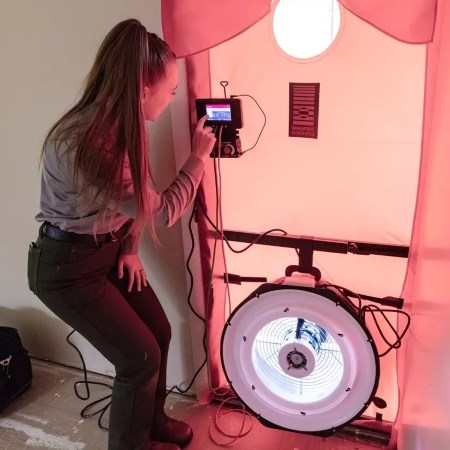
0,0,193,385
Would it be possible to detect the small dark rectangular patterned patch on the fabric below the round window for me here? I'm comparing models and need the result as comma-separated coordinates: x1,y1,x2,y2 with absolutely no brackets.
289,83,320,139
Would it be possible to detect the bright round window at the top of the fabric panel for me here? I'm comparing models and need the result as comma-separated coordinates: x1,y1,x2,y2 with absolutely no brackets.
273,0,341,59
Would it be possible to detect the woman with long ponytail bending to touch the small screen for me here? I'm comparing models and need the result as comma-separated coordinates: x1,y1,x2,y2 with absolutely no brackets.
28,19,216,450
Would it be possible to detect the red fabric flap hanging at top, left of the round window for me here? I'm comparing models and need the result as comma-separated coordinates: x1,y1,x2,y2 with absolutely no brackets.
161,0,272,58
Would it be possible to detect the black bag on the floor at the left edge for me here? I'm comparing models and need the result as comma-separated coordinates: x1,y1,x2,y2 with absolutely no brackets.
0,327,33,411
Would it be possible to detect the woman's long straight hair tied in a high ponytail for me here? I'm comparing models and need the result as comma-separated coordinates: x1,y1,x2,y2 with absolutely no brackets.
42,19,176,237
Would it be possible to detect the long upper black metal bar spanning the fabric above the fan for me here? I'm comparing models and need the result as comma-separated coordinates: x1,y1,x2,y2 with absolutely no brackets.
223,230,409,258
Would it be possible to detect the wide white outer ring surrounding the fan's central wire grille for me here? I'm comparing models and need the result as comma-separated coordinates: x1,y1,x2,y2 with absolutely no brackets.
222,285,379,433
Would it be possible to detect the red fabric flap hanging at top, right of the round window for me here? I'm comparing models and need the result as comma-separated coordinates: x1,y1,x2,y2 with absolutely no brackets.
339,0,437,44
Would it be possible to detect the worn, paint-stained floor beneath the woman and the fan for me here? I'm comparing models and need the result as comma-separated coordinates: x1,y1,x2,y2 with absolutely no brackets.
0,360,385,450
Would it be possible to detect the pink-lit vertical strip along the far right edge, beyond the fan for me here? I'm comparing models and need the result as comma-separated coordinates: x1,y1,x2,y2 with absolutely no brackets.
396,1,450,450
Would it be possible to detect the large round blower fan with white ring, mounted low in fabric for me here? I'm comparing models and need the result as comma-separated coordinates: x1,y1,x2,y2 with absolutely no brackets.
221,283,379,436
